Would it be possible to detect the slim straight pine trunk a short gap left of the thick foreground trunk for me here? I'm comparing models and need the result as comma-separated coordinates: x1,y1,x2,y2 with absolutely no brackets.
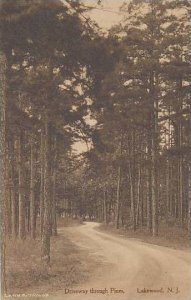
30,136,35,239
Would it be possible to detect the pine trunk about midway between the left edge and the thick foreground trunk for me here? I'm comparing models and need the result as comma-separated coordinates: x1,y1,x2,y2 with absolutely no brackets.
18,131,26,239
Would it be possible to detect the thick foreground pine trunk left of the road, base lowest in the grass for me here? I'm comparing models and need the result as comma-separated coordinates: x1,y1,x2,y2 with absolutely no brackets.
42,113,51,264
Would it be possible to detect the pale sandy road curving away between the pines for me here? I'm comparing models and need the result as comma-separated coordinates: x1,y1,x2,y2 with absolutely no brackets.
57,222,191,300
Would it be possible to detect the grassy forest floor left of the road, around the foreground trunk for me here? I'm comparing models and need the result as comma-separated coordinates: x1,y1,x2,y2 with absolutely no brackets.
5,219,99,299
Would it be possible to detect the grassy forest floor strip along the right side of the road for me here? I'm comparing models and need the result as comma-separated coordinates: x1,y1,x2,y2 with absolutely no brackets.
99,223,191,250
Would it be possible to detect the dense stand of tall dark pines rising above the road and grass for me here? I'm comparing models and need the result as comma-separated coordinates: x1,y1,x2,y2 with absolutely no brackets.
0,0,191,263
